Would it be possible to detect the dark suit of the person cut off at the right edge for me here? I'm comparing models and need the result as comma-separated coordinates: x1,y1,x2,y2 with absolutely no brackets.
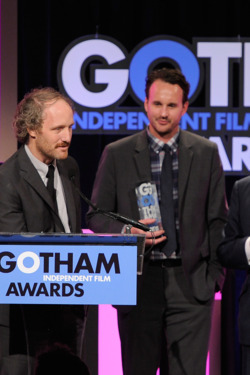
218,177,250,345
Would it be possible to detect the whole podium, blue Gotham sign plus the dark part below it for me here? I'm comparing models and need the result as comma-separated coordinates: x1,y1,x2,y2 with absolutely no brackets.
0,233,145,375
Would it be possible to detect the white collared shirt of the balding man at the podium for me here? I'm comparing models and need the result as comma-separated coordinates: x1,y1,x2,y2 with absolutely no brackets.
24,145,70,233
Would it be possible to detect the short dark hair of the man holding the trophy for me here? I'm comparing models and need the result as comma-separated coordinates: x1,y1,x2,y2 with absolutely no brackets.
145,68,190,104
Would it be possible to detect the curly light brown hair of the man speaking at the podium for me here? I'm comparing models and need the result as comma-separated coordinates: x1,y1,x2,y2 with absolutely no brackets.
13,87,74,143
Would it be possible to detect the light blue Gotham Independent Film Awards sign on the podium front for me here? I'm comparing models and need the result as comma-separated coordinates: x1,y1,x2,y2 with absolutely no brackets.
0,234,145,305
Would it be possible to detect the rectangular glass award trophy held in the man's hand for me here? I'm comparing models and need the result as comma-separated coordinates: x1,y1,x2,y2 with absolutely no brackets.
135,182,162,231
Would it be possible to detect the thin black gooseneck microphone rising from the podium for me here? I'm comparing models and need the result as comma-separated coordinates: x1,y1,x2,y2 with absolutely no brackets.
69,171,150,232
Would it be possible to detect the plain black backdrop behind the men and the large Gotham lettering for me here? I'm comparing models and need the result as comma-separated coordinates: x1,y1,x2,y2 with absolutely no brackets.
18,0,250,375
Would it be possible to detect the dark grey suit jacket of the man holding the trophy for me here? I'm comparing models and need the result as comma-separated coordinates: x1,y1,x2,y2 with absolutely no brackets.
87,130,227,301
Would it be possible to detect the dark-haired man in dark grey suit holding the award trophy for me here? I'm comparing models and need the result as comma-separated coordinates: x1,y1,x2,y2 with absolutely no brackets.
88,69,227,375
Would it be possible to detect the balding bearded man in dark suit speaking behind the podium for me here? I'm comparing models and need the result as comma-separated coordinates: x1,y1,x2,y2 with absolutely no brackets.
0,88,85,375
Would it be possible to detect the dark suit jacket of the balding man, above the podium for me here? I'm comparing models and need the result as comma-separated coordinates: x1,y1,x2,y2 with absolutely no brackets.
0,147,81,233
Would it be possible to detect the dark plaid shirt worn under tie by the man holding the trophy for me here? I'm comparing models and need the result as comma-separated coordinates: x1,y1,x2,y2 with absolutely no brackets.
147,128,179,260
